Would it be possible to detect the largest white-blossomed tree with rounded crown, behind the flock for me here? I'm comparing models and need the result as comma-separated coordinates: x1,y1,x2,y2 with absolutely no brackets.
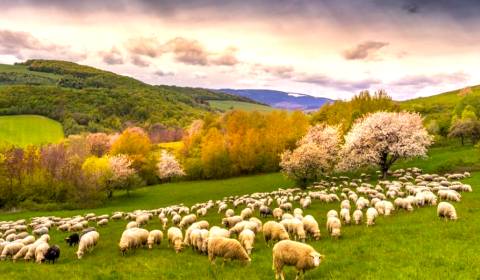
339,112,432,178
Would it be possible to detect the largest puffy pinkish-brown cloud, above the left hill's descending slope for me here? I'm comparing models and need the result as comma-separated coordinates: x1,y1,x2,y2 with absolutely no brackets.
126,37,239,66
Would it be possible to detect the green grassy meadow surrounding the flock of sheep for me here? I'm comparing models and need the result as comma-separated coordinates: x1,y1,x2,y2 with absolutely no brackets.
0,147,480,279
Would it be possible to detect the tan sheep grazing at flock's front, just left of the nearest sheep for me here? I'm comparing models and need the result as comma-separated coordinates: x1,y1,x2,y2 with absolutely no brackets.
208,237,250,264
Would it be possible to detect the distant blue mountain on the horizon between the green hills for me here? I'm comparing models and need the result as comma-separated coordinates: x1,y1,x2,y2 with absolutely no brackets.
218,89,333,111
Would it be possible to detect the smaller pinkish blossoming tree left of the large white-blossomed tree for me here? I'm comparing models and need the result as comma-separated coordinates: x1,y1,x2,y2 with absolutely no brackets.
280,124,340,188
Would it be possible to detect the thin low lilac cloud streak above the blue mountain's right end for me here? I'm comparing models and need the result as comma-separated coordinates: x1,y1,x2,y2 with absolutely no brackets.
294,74,381,91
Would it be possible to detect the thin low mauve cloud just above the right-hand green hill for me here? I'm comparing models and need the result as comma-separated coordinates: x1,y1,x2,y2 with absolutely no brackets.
391,72,470,88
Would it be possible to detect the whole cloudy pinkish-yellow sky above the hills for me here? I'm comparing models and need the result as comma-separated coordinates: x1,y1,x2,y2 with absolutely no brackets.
0,0,480,100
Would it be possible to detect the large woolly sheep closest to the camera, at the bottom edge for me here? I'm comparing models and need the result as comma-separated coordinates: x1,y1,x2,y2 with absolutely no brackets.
272,240,325,280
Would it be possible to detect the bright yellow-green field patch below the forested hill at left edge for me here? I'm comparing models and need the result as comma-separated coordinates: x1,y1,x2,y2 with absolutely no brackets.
0,115,63,147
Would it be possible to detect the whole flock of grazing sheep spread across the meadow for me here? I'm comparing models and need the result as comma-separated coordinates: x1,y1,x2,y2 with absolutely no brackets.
0,168,472,279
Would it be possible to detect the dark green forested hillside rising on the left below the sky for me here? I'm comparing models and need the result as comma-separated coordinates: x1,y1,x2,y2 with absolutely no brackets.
0,60,253,135
